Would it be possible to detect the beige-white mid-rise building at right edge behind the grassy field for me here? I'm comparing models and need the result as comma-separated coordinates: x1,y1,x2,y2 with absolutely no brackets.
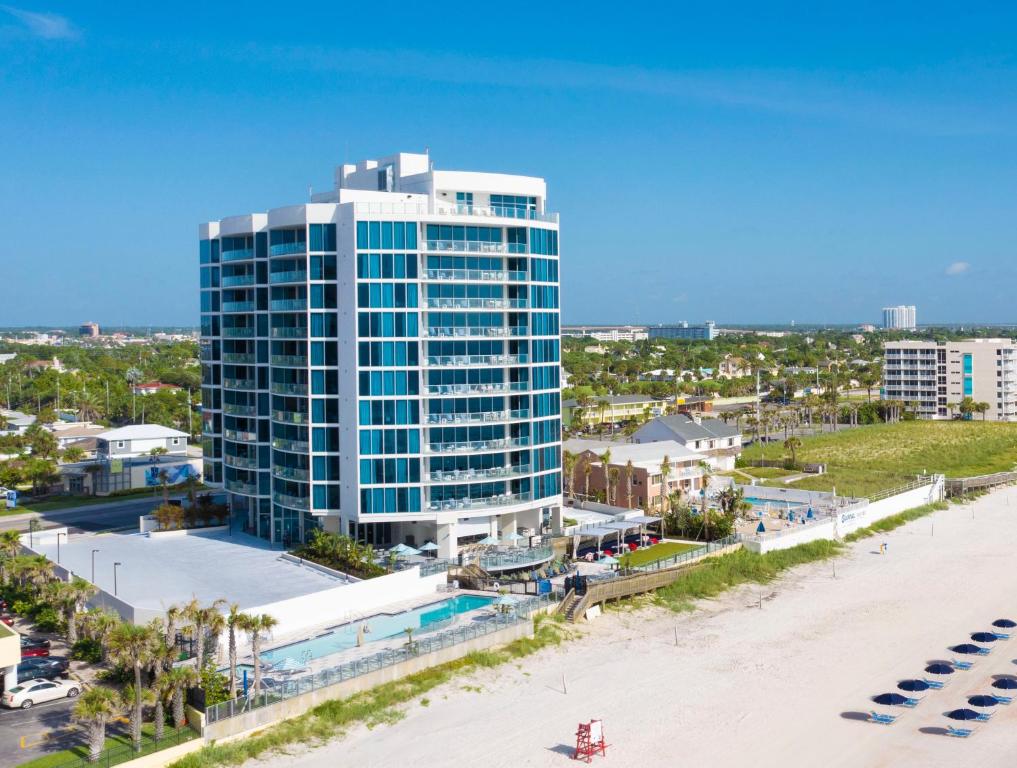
882,339,1017,421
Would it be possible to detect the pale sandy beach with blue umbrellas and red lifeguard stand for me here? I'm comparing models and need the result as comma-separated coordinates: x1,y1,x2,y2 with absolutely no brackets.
256,488,1017,768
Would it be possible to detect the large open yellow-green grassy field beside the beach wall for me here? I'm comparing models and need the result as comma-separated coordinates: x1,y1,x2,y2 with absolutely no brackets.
742,421,1017,496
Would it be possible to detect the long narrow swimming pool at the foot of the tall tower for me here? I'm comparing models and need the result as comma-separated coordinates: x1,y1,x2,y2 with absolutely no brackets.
261,595,495,663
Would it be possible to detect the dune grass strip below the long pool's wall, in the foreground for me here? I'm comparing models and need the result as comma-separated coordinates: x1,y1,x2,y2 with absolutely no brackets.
170,614,571,768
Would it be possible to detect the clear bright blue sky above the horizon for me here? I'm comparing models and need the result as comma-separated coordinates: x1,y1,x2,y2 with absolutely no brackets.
0,2,1017,326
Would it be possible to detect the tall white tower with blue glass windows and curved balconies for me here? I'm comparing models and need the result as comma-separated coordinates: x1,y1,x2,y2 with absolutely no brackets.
199,154,561,556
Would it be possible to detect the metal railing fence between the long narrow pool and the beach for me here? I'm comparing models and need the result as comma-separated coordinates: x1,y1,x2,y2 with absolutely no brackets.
202,592,561,724
